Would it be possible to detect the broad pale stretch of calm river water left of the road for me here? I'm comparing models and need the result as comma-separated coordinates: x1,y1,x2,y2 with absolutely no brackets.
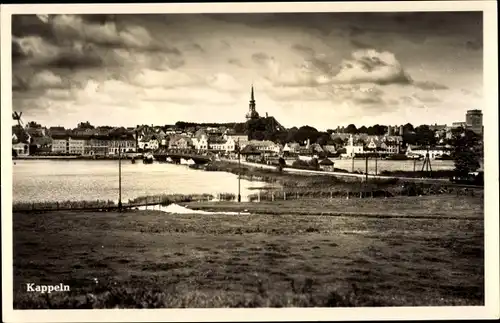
12,160,266,202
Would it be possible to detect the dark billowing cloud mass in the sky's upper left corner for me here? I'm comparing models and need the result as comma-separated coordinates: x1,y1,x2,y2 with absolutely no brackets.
12,15,184,69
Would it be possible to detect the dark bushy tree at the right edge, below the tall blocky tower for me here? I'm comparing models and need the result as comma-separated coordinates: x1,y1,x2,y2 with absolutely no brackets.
451,129,483,174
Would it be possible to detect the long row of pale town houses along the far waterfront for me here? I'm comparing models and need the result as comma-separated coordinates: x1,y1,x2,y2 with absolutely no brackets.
12,125,460,158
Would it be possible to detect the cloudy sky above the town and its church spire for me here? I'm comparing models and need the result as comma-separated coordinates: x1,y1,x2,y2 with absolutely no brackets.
12,12,483,130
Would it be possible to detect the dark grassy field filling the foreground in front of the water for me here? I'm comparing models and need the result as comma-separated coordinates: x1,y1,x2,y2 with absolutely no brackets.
14,196,484,308
